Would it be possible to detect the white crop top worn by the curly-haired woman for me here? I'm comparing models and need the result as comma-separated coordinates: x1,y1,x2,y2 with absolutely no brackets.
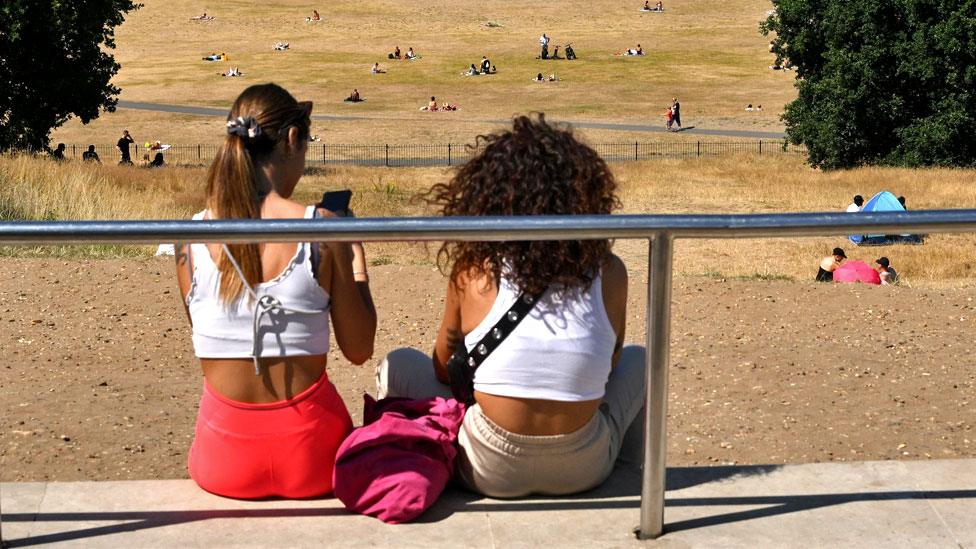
464,276,617,402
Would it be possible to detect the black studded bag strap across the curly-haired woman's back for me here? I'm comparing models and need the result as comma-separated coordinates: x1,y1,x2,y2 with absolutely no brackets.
447,293,542,406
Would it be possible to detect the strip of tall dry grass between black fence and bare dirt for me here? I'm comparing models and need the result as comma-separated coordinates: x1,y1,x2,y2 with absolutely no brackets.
0,152,976,287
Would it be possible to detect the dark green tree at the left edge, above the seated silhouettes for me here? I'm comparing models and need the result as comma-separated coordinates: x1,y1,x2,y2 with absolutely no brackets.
0,0,141,151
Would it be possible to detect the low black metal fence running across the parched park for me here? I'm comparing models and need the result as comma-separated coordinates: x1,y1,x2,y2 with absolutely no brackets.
65,139,806,167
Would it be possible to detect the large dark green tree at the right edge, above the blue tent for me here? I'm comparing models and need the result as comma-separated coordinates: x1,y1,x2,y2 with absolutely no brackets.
760,0,976,169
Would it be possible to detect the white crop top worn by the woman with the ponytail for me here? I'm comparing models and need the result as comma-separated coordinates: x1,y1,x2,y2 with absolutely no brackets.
186,206,330,363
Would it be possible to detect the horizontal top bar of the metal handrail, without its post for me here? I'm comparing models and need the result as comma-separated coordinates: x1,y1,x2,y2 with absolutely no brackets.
0,210,976,245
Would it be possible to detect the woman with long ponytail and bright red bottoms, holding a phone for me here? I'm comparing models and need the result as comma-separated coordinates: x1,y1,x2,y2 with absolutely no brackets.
176,84,376,499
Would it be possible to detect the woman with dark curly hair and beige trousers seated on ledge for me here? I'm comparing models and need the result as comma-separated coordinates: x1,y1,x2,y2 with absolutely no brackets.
377,114,645,497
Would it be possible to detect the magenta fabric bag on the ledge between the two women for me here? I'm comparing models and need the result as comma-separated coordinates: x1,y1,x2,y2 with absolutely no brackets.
332,395,464,524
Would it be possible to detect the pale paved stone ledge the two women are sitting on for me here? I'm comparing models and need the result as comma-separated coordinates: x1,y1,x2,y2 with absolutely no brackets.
0,459,976,549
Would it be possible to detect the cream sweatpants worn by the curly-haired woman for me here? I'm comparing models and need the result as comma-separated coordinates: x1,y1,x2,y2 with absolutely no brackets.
376,346,645,498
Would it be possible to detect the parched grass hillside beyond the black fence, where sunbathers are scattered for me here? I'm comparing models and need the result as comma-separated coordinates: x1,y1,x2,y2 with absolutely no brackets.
47,0,794,144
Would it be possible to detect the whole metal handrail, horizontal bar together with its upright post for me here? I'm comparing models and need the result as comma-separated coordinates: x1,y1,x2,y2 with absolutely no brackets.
0,209,976,539
